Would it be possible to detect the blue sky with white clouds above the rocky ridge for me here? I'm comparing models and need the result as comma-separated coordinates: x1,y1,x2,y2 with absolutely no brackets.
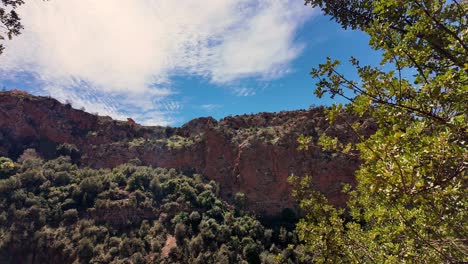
0,0,379,126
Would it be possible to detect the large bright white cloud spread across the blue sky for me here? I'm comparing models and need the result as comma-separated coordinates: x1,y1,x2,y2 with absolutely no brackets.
0,0,311,124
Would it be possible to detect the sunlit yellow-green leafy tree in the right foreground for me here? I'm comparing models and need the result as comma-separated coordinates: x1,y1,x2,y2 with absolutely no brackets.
291,0,468,263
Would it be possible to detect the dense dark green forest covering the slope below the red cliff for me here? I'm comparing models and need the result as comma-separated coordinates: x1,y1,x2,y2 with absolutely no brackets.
0,149,308,263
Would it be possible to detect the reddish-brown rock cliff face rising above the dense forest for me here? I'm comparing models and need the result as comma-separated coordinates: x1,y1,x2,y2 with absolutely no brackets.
0,92,374,215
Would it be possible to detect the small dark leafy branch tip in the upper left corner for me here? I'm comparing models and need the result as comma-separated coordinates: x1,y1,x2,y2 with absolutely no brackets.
0,0,24,54
